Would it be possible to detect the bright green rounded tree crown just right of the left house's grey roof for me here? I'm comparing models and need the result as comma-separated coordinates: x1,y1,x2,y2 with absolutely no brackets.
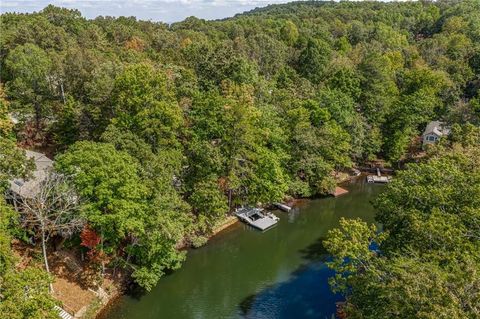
56,142,148,242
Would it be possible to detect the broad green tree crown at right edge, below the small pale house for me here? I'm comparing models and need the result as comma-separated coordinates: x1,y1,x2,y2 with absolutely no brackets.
376,148,480,260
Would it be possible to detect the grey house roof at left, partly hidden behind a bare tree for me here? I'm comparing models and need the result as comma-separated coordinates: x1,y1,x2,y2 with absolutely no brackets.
10,150,53,198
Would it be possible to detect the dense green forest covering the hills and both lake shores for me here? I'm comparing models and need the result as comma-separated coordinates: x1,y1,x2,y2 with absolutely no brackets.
0,0,480,318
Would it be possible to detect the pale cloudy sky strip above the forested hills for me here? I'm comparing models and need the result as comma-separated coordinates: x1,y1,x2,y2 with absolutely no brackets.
0,0,292,23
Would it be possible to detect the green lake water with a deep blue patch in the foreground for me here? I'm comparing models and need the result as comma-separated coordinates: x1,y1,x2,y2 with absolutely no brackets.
101,180,382,319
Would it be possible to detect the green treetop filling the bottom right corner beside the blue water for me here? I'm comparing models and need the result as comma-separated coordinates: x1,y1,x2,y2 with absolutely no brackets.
347,257,480,319
